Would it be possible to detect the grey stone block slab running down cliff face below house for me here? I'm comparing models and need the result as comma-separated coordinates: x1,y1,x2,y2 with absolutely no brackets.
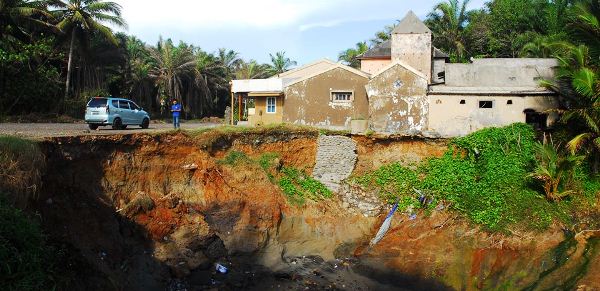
313,135,358,192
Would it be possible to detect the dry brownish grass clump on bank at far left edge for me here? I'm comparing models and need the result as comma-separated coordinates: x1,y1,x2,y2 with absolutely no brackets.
0,136,45,207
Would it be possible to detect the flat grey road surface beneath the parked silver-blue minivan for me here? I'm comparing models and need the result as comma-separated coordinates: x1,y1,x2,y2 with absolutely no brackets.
0,123,218,139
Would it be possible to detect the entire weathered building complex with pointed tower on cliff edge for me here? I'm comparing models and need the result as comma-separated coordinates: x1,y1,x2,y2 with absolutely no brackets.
232,11,558,137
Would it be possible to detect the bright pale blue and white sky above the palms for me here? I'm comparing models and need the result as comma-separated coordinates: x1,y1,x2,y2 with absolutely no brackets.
114,0,485,65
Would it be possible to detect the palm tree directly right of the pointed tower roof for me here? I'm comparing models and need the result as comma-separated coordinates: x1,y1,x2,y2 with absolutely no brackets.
426,0,471,62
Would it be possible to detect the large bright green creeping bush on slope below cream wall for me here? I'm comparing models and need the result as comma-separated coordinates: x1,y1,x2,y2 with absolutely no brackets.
354,124,561,231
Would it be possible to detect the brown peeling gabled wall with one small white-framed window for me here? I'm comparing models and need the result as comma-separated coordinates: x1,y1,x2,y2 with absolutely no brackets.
283,68,369,129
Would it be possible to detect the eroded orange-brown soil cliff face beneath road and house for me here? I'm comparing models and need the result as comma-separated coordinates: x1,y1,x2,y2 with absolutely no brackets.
30,131,600,290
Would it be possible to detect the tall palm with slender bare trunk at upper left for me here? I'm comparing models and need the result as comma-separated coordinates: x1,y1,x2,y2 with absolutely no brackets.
51,0,127,100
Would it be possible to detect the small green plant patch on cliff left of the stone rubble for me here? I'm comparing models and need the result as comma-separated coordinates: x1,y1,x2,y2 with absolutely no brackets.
278,167,333,205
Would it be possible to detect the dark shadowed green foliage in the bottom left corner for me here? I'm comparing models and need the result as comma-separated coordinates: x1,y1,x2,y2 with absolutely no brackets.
0,195,50,290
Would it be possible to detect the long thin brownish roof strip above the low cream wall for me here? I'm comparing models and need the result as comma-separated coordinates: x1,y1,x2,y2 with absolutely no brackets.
429,85,556,96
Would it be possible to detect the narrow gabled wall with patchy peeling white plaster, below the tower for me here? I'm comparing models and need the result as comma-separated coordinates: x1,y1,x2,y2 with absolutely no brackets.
367,64,429,133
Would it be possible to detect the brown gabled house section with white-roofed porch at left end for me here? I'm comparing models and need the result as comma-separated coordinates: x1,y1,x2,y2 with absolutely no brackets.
232,59,369,128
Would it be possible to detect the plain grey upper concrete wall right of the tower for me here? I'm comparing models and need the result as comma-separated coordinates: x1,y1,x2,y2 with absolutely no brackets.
446,59,558,87
